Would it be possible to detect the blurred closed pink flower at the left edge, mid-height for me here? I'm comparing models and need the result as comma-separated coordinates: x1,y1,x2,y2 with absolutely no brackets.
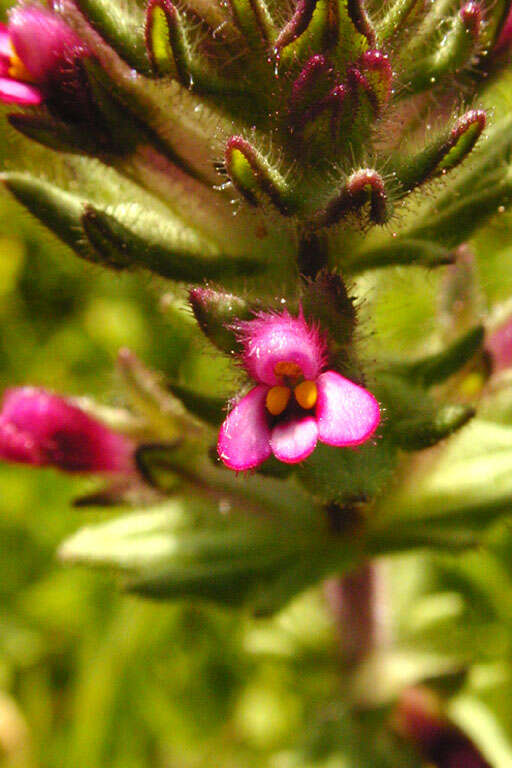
0,387,133,472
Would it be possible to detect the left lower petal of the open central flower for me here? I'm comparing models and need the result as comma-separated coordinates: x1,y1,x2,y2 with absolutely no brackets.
217,384,271,472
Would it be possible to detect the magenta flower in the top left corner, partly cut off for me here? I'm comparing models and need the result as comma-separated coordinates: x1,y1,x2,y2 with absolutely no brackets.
0,4,89,106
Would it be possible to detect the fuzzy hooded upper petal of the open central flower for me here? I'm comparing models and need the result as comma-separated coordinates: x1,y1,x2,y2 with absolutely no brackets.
237,311,325,387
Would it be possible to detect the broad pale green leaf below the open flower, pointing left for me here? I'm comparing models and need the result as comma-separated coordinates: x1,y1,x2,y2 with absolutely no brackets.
59,497,348,610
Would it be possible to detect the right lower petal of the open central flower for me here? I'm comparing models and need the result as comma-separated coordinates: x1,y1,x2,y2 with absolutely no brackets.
316,371,380,447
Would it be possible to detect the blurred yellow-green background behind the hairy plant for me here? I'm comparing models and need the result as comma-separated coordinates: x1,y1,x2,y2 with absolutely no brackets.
0,7,512,768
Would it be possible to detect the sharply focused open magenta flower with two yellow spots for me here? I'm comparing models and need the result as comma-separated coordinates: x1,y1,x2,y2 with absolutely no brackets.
217,311,380,471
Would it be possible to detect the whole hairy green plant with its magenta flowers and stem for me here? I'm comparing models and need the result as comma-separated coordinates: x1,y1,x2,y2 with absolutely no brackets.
0,0,512,768
